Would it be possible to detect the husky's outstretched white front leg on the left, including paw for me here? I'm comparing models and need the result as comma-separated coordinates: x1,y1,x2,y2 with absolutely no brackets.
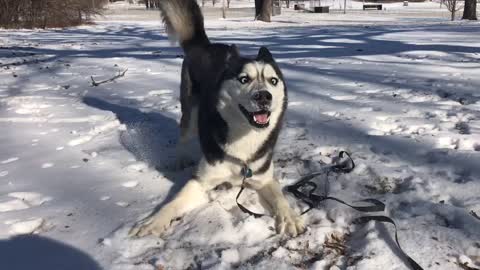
129,179,208,237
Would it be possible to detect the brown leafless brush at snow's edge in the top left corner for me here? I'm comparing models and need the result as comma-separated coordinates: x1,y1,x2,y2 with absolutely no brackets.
0,0,108,28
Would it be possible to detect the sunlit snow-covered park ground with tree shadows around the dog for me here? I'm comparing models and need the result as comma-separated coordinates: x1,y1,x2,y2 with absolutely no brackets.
0,4,480,270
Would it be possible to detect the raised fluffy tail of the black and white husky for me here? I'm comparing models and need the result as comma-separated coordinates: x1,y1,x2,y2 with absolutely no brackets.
160,0,210,53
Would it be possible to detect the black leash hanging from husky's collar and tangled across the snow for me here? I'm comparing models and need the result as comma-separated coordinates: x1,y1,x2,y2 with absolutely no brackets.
236,151,423,270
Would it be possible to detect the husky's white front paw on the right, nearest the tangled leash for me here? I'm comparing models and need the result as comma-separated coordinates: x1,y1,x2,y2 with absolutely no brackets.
275,204,305,237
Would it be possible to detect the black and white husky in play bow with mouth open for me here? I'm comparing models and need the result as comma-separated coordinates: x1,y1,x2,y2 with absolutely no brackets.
130,0,304,236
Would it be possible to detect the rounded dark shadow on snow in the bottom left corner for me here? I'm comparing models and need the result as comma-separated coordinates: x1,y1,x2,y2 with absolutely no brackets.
0,235,102,270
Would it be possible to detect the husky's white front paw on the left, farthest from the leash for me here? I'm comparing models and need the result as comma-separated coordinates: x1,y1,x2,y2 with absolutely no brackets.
128,214,172,237
